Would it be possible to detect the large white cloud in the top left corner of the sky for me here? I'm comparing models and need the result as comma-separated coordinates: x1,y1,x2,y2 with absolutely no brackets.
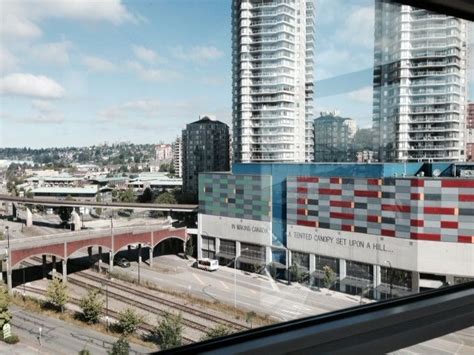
0,0,140,39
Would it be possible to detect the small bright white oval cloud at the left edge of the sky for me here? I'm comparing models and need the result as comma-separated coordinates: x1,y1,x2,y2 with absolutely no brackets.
0,73,64,99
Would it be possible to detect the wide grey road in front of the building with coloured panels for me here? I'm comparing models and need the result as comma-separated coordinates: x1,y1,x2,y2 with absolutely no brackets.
117,255,359,321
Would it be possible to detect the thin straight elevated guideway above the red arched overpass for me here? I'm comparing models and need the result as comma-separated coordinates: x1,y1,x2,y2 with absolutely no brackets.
0,194,198,212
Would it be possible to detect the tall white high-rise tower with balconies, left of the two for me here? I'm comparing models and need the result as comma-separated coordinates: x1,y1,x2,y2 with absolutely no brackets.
232,0,314,163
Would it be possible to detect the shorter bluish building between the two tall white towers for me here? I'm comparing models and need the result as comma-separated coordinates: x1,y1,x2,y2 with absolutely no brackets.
314,111,357,162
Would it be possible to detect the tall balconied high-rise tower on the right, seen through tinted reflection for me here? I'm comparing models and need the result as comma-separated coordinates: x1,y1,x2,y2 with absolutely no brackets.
373,0,467,162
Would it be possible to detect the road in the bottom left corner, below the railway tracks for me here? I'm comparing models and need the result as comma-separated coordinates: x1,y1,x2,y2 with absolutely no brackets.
0,307,153,355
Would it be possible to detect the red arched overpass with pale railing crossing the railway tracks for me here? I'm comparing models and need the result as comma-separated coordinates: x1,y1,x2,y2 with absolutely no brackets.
0,224,187,292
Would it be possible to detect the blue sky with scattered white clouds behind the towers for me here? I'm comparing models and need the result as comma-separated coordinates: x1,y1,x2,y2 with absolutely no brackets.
0,0,474,148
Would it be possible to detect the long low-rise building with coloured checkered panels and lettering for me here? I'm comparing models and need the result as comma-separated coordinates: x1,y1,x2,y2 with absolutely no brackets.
198,163,474,298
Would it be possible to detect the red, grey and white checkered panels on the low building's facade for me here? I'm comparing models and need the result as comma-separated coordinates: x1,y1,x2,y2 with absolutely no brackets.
287,176,474,243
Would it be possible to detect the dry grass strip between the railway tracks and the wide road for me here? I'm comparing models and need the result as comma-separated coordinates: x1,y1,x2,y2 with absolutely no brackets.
110,271,276,327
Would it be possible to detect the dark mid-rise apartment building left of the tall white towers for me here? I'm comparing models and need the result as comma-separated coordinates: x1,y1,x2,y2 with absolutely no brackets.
182,116,230,194
